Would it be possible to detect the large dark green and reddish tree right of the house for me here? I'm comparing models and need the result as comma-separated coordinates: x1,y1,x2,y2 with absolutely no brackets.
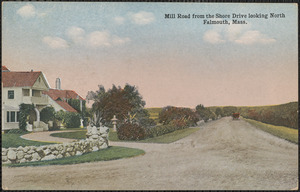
87,84,151,127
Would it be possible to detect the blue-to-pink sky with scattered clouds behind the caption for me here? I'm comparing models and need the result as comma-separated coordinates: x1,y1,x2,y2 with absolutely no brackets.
2,2,298,107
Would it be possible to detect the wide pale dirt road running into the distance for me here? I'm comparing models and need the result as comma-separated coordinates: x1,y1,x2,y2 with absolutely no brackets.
2,118,298,190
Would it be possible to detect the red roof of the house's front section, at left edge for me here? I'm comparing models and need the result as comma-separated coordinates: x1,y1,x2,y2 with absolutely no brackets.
2,71,42,87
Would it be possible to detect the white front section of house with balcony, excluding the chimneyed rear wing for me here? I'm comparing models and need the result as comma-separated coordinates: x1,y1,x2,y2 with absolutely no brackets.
1,66,50,131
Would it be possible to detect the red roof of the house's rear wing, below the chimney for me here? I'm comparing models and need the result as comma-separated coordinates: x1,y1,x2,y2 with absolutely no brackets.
43,89,84,101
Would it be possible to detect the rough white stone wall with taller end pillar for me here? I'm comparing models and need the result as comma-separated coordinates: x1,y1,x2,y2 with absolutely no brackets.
2,127,109,164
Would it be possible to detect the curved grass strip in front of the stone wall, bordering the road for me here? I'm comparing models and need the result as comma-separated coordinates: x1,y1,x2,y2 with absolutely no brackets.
4,146,145,167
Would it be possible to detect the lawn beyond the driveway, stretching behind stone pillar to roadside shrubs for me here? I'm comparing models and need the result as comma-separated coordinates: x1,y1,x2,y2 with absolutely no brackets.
51,128,200,143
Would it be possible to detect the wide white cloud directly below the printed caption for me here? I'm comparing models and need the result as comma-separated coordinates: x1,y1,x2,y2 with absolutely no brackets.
203,22,276,45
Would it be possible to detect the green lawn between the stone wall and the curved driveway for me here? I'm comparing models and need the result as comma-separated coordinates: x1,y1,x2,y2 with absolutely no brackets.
2,133,54,148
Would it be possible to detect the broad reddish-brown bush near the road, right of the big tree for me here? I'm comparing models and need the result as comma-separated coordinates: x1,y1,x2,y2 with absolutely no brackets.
159,106,199,126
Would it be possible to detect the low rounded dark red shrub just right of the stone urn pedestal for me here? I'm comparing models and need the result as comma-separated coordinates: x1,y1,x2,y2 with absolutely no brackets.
117,122,146,140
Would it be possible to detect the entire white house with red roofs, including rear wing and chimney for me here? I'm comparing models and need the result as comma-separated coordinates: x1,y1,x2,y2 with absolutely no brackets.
1,66,84,131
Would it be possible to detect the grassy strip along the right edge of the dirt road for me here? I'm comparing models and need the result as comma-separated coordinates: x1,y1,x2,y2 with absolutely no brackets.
243,118,298,144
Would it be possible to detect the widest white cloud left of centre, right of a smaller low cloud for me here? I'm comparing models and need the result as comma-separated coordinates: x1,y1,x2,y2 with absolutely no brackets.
66,26,130,48
